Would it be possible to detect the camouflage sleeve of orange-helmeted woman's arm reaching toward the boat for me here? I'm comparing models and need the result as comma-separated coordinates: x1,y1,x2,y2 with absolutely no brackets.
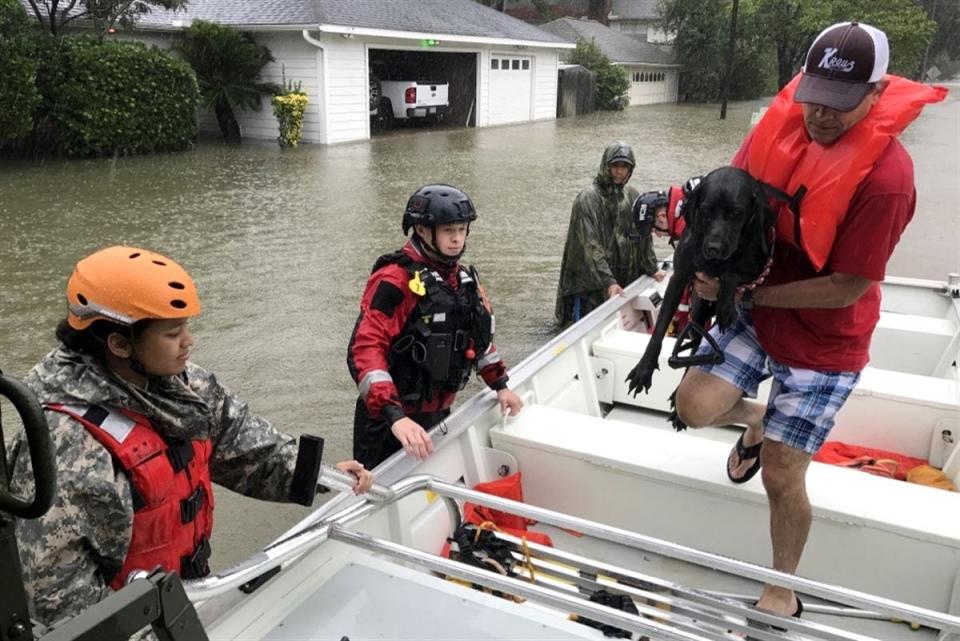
188,364,298,502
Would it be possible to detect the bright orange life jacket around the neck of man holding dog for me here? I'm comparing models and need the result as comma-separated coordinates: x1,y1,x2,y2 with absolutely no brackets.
744,74,947,271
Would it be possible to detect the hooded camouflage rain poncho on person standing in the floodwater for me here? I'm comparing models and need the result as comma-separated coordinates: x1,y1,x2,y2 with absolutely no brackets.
555,143,657,327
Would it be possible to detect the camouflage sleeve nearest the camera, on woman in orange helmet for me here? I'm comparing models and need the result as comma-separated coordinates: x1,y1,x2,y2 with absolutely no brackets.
11,412,133,625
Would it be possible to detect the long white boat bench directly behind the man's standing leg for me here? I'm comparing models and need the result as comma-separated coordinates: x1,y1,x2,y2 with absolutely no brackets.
490,403,960,609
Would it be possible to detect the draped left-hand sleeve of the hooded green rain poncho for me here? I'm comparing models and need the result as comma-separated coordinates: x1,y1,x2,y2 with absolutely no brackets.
561,190,617,295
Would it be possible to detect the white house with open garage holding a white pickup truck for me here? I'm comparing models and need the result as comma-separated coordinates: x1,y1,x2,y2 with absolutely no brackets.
39,0,573,144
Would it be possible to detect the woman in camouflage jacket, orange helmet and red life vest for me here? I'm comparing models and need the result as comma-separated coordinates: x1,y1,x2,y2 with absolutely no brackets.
11,247,373,625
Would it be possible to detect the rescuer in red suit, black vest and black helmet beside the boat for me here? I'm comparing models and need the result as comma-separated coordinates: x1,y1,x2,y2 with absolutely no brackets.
347,185,523,469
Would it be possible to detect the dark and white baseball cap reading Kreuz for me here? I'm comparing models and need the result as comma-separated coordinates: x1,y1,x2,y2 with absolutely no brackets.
793,22,890,111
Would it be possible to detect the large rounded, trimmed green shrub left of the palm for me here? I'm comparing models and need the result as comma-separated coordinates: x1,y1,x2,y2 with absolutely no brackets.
42,36,197,156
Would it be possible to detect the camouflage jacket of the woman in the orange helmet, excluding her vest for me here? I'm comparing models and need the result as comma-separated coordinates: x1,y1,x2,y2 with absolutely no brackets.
10,345,297,625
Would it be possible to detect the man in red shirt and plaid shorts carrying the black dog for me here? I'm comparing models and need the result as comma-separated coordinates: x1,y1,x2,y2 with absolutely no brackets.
676,22,945,616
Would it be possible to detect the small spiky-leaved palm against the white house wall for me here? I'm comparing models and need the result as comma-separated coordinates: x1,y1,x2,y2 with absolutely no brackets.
175,20,278,143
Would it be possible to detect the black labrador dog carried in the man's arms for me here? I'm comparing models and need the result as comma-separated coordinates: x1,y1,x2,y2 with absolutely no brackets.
626,167,776,396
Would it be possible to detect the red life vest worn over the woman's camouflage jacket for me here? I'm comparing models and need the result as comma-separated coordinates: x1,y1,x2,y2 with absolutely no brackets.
46,403,213,590
